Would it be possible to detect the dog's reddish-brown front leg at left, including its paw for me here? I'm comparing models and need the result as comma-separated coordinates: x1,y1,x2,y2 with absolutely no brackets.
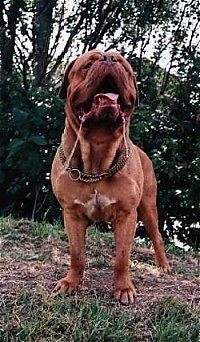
54,211,88,294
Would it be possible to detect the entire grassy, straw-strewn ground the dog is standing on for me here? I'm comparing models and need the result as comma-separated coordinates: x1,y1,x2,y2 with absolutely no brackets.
0,217,200,342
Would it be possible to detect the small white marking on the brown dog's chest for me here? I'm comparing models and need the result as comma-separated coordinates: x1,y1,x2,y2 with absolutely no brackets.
74,190,117,217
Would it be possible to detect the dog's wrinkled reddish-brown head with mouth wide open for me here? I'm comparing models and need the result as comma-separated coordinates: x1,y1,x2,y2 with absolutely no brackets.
60,50,137,125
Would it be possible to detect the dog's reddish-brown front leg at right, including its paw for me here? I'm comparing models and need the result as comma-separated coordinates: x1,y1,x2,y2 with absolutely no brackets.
114,210,137,305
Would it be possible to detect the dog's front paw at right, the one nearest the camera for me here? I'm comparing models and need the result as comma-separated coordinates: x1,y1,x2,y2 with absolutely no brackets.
114,280,136,305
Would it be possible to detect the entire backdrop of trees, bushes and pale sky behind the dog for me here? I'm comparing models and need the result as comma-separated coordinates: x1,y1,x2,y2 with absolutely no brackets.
0,0,200,247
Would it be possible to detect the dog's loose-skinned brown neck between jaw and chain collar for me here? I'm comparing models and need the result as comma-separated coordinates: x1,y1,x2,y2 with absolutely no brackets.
63,125,128,174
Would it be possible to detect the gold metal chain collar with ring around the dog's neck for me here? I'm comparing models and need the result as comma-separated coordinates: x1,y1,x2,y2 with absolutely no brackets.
59,145,130,183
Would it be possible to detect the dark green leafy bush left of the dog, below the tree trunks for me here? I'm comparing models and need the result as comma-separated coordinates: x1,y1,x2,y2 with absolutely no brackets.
0,76,64,219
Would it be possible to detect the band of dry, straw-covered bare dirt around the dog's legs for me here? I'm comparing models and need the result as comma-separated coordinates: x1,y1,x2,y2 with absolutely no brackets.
0,235,200,311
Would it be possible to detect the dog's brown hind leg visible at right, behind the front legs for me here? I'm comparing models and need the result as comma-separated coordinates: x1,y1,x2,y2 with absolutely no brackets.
138,203,170,272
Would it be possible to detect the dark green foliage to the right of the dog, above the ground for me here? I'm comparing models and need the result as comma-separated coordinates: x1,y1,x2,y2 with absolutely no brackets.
131,52,200,248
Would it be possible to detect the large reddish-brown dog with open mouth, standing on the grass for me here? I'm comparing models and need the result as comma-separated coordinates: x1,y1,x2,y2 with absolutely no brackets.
51,50,169,304
